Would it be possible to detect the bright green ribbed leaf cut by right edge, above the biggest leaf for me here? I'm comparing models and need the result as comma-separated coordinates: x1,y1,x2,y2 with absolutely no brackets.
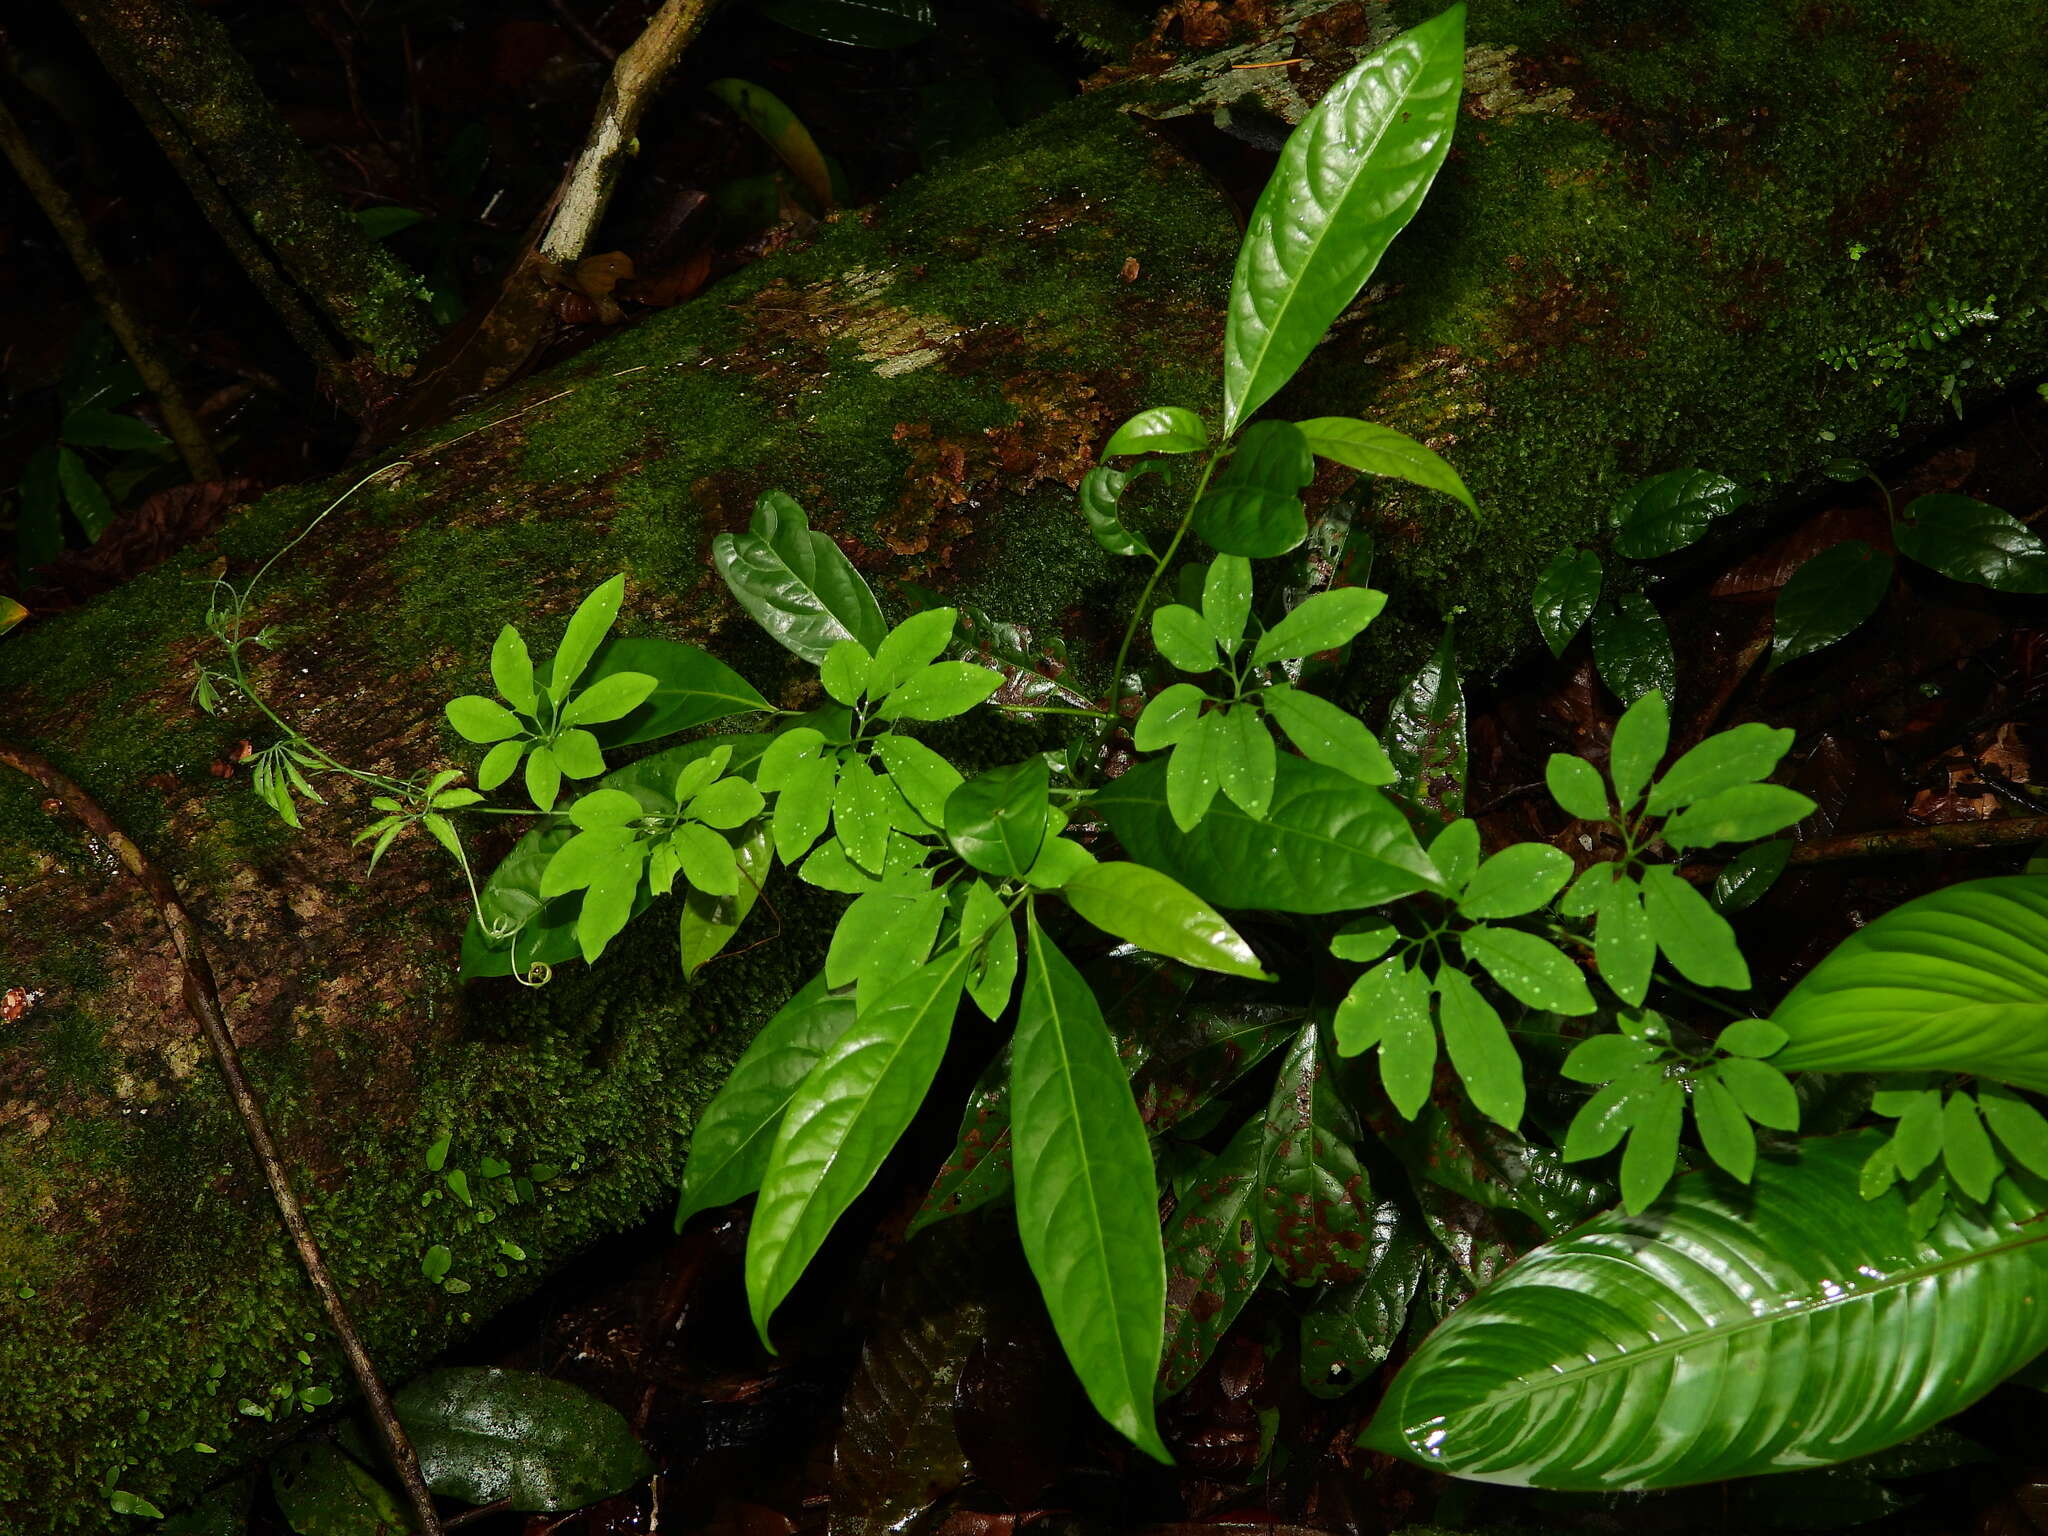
1772,874,2048,1092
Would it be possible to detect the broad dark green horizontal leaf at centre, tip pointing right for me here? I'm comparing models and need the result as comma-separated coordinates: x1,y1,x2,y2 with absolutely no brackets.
1094,756,1442,911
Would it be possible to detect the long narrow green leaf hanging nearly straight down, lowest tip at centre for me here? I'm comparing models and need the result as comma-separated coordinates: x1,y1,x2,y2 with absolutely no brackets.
1011,913,1171,1460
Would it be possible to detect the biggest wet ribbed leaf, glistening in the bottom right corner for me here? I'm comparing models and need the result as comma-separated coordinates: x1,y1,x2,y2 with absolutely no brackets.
1364,1133,2048,1491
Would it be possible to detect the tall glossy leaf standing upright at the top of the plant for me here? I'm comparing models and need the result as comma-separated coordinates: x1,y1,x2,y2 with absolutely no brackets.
1223,4,1464,436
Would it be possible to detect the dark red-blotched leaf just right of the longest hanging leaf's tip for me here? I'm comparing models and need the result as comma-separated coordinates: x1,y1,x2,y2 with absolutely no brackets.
1159,1116,1272,1397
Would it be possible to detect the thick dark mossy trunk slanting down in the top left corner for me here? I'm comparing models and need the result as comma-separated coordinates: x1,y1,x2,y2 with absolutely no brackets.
66,0,436,412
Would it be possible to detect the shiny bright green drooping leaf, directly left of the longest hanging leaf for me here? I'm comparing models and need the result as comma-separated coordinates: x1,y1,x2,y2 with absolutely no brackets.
745,946,966,1341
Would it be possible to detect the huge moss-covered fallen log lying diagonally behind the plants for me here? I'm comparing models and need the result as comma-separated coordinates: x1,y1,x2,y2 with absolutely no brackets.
0,0,2048,1532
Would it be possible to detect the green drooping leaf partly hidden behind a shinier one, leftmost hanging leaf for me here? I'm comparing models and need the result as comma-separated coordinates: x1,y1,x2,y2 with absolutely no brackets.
676,975,854,1231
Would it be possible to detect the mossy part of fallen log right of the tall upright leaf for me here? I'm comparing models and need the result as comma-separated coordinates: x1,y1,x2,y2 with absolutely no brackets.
1276,2,2048,676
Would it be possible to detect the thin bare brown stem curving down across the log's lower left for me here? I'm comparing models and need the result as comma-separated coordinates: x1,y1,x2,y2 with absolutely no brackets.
0,739,442,1536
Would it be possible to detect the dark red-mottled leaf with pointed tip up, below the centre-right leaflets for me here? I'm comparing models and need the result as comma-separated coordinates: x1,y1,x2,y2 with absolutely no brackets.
1253,1020,1372,1286
